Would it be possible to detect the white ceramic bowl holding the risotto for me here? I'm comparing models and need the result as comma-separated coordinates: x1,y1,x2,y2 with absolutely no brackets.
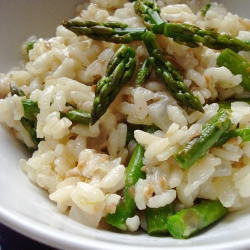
0,0,250,250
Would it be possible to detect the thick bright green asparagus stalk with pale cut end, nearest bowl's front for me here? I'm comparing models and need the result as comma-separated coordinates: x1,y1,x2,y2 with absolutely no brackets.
167,200,228,239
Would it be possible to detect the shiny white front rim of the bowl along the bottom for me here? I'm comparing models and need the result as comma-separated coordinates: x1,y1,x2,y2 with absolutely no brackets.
0,195,250,250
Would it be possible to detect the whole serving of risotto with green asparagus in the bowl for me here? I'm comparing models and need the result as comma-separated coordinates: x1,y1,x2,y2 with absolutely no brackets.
0,0,250,239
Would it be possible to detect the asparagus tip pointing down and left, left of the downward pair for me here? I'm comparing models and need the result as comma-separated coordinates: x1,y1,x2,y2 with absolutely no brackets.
91,44,137,124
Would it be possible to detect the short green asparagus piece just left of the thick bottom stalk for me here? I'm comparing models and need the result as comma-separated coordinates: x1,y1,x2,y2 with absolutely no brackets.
146,203,174,235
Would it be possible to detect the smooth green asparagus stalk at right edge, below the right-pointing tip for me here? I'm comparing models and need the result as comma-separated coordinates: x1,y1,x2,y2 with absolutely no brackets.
216,49,250,91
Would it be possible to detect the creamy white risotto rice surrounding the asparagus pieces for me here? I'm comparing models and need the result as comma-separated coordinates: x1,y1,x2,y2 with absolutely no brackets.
0,0,250,238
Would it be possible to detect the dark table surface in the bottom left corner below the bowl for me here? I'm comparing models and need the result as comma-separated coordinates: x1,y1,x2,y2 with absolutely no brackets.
0,223,56,250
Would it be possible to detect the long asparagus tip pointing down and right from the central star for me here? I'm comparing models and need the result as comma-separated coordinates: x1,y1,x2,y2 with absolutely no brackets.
143,32,203,111
